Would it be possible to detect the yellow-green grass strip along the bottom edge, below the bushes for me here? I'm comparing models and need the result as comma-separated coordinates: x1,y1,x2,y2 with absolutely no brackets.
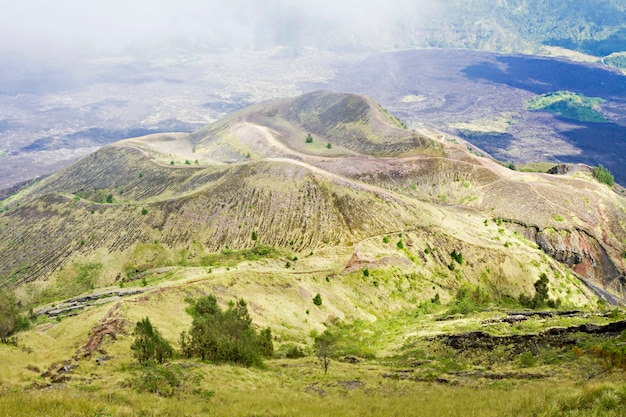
0,359,626,417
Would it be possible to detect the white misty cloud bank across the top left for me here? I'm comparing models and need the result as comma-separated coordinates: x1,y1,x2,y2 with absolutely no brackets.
0,0,433,53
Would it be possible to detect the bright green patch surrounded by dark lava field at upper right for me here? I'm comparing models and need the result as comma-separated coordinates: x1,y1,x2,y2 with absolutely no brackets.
526,91,611,123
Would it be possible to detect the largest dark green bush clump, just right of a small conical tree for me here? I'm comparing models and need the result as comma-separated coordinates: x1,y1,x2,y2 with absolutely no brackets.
181,295,274,366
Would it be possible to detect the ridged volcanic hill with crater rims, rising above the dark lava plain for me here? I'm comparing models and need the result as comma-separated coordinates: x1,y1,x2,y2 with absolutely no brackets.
0,91,626,309
